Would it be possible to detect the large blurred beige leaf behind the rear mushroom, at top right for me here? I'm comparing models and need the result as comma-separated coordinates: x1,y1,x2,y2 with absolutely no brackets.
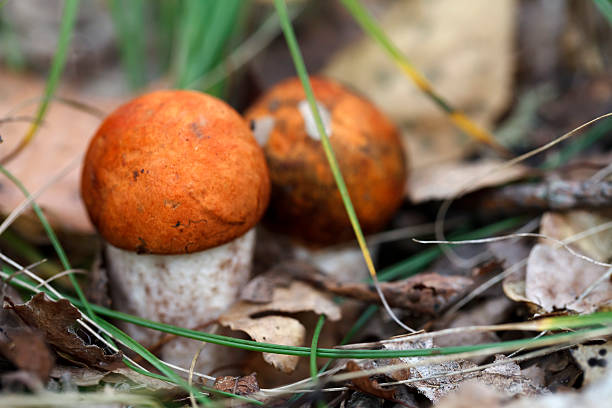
324,0,515,168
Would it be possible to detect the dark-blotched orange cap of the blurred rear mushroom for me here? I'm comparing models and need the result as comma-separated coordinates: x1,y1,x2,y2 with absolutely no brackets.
245,77,407,245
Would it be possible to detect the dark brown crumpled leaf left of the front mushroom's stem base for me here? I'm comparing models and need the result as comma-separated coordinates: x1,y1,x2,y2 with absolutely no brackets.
9,293,123,371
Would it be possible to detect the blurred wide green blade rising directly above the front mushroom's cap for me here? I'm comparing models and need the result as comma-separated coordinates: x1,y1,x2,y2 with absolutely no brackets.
109,0,147,89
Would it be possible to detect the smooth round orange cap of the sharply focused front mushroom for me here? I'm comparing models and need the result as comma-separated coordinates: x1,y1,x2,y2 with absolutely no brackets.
81,91,270,254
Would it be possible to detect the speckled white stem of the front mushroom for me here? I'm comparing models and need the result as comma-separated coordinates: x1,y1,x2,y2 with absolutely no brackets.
106,229,255,372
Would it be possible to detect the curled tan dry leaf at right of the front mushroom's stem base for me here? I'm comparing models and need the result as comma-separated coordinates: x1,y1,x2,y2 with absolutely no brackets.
219,282,340,373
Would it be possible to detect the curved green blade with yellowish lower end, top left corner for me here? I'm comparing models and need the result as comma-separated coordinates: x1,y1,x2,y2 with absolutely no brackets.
0,0,79,164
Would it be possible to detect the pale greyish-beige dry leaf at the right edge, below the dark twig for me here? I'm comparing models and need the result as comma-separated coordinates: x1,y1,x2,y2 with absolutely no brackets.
525,244,612,313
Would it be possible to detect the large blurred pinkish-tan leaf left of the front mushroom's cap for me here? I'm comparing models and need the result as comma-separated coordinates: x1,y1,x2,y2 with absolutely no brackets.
0,71,117,236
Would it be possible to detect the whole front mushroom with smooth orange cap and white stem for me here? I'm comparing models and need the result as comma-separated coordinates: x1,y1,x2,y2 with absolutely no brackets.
81,91,270,369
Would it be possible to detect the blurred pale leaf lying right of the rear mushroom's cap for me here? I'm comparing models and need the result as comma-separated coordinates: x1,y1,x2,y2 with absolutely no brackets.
406,159,529,203
